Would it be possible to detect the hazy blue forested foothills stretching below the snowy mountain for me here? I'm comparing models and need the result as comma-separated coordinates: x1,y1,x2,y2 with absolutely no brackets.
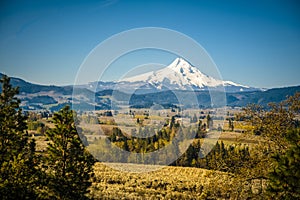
0,70,300,111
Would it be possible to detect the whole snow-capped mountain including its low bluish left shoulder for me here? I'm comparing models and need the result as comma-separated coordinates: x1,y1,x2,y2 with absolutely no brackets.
89,58,259,93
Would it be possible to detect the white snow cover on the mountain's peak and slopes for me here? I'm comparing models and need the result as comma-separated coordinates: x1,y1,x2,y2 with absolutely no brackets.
118,58,253,91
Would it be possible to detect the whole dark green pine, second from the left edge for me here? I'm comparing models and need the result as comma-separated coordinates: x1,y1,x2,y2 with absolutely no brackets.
45,106,94,199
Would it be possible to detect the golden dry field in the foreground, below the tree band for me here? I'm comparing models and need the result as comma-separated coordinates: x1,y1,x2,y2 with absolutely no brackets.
91,163,241,199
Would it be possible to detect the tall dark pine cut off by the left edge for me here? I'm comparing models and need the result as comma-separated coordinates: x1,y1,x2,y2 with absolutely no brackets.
0,75,39,199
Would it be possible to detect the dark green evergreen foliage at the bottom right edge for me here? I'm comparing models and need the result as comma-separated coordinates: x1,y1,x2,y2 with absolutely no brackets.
268,129,300,199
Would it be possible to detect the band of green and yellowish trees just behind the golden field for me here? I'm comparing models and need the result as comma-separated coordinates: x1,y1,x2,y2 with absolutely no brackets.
90,113,250,172
